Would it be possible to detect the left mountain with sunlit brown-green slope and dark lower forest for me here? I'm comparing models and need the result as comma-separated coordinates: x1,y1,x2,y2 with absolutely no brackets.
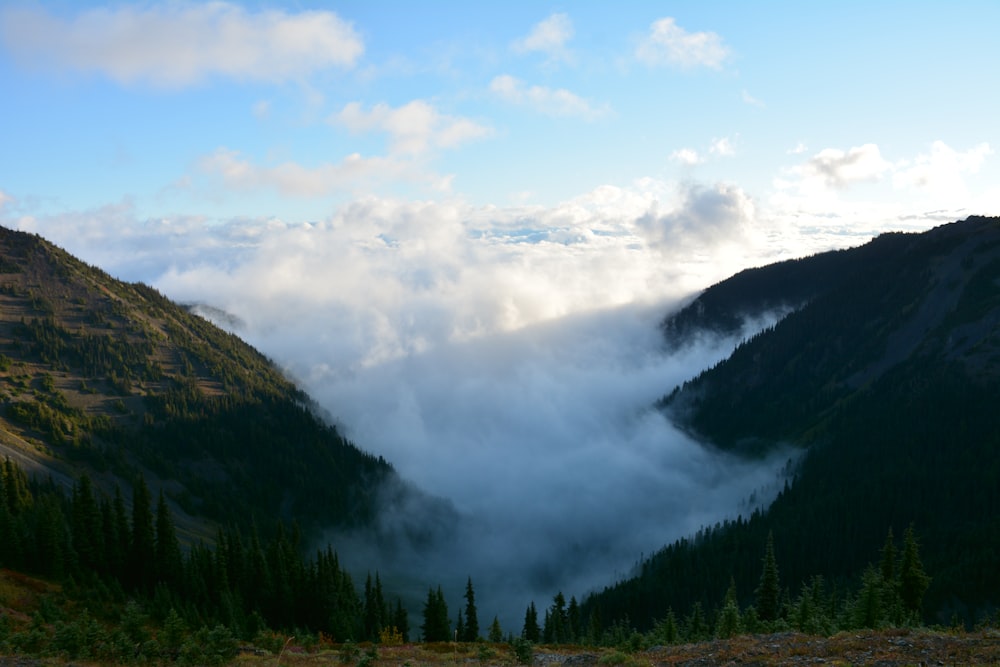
0,229,406,534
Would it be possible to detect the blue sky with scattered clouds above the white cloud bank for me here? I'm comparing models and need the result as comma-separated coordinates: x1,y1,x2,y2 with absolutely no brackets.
0,2,1000,231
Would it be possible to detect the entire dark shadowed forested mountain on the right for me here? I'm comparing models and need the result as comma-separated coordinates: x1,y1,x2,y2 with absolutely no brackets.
584,217,1000,628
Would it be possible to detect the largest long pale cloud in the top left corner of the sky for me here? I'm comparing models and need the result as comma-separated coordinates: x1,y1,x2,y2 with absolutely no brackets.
0,2,364,88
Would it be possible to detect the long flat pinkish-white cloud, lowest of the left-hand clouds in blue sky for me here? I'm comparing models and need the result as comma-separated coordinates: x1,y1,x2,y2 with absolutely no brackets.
198,148,447,197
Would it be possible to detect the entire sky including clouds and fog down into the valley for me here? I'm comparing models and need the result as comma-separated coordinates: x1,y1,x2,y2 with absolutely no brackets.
0,0,1000,628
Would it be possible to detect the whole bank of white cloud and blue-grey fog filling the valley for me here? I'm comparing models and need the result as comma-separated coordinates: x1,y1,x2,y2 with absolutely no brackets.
9,184,824,632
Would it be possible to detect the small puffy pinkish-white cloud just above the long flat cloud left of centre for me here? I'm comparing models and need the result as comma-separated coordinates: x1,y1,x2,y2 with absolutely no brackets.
329,100,492,155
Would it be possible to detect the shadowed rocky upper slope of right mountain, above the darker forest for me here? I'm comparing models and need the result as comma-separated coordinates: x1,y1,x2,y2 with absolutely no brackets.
663,218,1000,454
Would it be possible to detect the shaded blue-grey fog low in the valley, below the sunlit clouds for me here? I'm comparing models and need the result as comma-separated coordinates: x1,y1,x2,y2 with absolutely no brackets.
309,304,790,632
